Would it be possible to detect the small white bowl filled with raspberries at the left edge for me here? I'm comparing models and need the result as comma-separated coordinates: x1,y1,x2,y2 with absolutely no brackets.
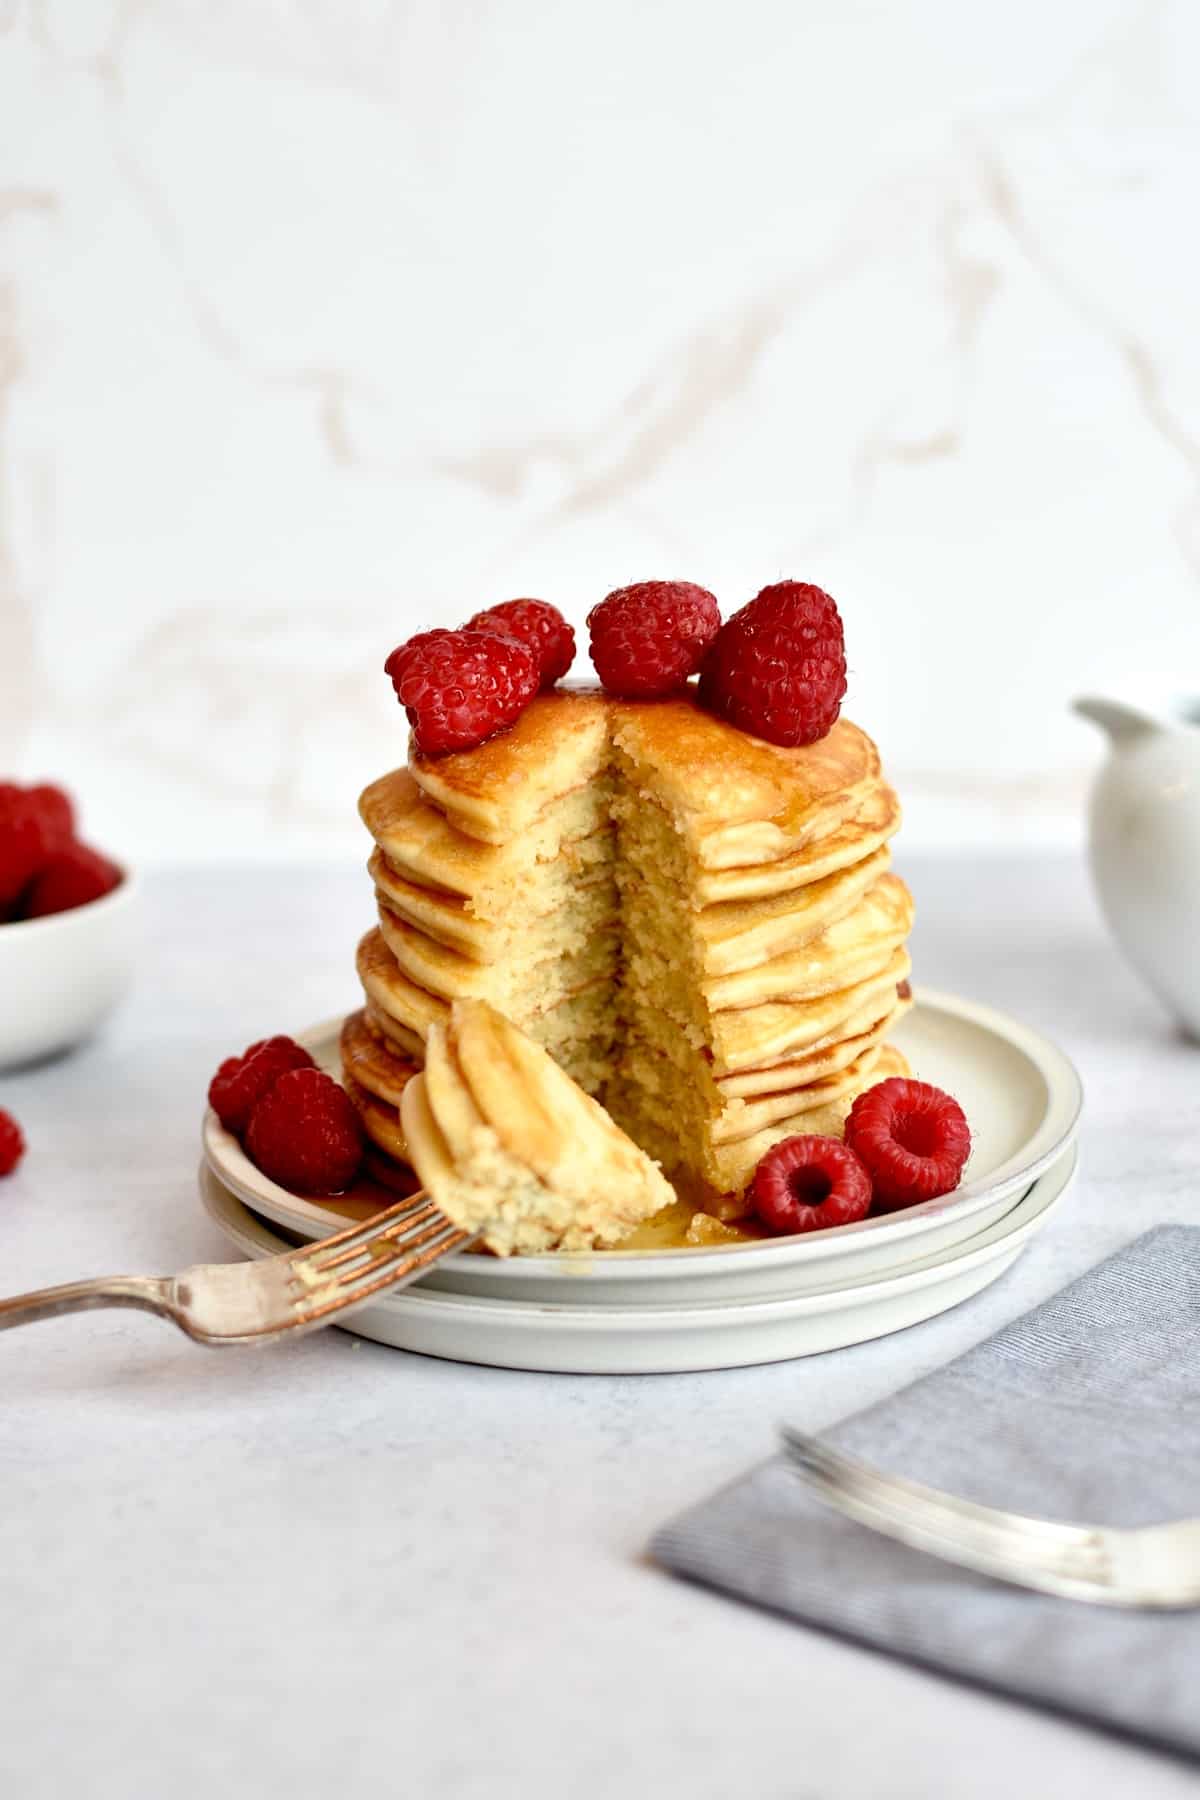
0,781,137,1067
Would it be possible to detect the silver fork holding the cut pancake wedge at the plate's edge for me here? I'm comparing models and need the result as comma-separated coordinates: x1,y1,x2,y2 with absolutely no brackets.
0,1193,475,1345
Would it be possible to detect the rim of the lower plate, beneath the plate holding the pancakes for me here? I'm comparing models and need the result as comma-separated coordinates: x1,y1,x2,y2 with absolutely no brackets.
200,1143,1079,1336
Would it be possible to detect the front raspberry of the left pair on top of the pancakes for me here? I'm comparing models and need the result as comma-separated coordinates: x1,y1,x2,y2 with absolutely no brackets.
383,630,540,756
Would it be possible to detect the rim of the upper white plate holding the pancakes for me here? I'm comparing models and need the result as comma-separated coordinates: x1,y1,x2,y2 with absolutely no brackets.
201,985,1083,1282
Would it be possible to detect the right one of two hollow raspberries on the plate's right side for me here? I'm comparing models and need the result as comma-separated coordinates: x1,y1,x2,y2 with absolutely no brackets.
846,1075,972,1213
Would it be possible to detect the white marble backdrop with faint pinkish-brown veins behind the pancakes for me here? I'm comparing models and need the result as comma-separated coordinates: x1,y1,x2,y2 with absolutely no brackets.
0,0,1200,859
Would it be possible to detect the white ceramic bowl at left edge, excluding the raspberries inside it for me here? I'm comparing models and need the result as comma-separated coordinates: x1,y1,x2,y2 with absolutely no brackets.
0,871,140,1069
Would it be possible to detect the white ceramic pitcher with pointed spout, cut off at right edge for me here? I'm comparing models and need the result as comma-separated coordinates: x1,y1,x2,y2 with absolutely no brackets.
1074,698,1200,1039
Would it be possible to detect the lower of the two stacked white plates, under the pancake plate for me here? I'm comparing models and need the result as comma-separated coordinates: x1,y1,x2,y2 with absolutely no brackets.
200,1148,1078,1375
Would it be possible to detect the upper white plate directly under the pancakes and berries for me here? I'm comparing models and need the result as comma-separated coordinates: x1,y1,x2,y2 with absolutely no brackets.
203,990,1083,1307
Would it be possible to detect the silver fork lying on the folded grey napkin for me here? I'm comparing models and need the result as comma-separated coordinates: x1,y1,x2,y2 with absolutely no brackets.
781,1426,1200,1607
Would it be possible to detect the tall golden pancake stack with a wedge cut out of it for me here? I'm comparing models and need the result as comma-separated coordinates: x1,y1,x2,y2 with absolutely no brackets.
344,689,912,1215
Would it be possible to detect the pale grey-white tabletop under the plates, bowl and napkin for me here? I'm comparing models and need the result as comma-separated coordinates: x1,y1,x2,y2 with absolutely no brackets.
0,859,1200,1800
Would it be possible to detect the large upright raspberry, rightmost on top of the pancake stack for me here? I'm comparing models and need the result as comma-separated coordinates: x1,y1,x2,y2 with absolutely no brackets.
700,581,846,745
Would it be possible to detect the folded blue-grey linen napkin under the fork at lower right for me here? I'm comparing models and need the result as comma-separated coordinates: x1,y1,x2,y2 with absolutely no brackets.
651,1226,1200,1759
